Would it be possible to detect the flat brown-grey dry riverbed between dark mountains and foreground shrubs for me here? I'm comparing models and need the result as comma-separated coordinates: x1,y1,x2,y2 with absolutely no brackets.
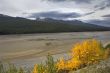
0,31,110,66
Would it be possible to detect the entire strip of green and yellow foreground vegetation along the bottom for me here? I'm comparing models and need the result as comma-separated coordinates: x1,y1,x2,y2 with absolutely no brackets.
0,39,110,73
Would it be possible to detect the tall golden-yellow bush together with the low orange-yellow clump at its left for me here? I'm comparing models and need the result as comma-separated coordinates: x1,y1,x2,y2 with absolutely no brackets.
57,39,104,71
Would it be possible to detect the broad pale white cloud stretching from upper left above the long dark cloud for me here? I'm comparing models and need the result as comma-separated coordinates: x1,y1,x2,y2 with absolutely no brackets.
0,0,81,16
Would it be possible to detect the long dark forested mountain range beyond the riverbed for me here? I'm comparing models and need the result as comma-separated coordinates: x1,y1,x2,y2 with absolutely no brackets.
0,14,110,34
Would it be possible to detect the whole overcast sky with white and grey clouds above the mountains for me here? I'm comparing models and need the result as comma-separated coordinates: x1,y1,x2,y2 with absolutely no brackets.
0,0,110,26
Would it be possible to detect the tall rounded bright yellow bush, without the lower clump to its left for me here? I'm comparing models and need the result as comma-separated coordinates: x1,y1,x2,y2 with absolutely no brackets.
72,39,103,65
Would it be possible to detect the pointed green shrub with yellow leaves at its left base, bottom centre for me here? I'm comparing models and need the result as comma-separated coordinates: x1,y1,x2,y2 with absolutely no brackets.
33,54,57,73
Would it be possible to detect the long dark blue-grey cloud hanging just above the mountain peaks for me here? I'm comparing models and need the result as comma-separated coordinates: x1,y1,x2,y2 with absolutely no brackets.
29,11,81,19
